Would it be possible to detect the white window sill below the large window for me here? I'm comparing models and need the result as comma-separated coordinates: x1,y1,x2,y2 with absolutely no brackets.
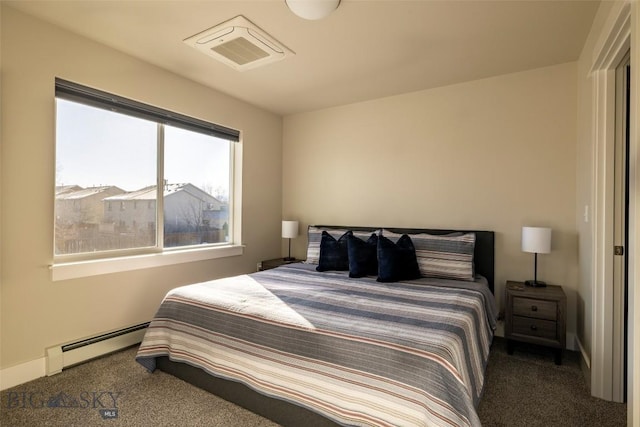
51,245,244,282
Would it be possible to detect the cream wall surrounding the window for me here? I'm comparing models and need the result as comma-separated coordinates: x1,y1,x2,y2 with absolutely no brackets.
0,4,282,369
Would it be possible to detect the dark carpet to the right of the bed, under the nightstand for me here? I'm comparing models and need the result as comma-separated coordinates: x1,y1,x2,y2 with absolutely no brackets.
478,338,627,427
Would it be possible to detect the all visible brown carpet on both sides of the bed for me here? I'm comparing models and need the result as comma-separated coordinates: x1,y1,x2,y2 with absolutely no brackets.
0,338,626,427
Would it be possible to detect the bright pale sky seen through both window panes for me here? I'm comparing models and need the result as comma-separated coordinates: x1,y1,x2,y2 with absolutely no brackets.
56,99,231,196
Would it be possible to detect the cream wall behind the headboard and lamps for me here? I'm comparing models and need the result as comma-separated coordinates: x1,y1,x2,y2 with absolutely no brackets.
283,63,578,342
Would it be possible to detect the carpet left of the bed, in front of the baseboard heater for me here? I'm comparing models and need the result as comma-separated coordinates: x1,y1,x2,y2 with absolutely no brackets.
0,348,277,427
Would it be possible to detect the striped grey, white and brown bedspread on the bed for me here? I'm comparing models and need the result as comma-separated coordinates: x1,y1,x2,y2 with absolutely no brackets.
136,264,497,426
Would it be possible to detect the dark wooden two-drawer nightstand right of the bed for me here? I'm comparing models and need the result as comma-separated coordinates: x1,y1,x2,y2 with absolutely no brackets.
504,281,567,365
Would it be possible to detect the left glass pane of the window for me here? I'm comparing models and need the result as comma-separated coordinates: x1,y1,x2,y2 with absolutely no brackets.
55,99,157,255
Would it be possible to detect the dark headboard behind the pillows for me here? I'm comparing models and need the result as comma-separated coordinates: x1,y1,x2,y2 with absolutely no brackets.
314,225,495,292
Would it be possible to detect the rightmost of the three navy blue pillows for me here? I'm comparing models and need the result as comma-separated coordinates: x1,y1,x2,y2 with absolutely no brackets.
377,234,420,282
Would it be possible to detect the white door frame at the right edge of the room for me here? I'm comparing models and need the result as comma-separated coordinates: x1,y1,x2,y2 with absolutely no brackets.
591,2,635,401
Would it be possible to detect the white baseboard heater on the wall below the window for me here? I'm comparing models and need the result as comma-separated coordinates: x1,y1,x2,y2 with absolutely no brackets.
46,322,149,376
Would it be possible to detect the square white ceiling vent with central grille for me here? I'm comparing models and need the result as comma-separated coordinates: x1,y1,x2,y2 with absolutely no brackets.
184,15,295,71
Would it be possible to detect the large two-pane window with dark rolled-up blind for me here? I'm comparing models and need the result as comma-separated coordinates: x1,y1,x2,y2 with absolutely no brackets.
54,79,239,262
